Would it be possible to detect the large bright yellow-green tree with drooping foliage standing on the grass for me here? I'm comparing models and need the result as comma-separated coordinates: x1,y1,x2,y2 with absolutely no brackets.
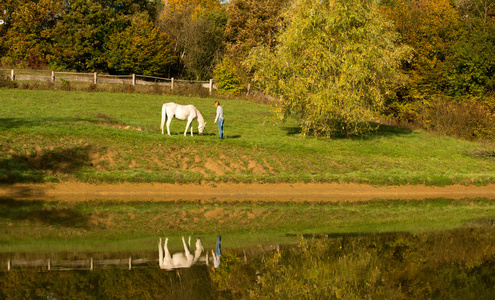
246,0,408,136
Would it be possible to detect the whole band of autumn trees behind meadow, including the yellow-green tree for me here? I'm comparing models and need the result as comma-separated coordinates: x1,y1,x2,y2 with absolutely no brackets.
0,0,495,139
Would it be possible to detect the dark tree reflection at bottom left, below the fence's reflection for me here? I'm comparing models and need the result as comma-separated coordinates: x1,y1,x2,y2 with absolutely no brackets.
0,265,218,299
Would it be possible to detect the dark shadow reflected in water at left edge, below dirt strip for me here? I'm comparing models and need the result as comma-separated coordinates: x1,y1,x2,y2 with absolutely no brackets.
0,198,89,229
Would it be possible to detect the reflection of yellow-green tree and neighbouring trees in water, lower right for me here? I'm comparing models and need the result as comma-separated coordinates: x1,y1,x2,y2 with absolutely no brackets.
239,226,495,299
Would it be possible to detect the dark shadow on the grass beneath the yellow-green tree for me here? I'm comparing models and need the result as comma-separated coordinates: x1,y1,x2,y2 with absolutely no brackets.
282,123,413,140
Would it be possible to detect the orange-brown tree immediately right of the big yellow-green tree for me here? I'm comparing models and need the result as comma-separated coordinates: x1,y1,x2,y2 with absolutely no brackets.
383,0,461,101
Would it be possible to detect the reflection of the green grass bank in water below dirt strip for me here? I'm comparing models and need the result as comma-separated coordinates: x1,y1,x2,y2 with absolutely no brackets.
0,199,495,252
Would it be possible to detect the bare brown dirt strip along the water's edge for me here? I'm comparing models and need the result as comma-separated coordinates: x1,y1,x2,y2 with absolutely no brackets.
0,183,495,202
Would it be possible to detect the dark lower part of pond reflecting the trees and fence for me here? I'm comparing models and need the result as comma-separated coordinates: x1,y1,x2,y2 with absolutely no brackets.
0,226,495,299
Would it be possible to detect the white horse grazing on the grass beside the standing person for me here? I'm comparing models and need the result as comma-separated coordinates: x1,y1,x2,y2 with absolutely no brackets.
160,102,206,136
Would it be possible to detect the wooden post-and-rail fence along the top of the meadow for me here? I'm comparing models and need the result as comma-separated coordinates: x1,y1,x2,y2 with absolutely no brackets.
0,69,216,94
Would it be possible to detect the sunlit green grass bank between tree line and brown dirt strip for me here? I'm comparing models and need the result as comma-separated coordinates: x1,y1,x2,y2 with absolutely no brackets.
0,89,495,186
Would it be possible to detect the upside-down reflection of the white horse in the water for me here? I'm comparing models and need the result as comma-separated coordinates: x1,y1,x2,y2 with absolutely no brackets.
158,237,204,270
